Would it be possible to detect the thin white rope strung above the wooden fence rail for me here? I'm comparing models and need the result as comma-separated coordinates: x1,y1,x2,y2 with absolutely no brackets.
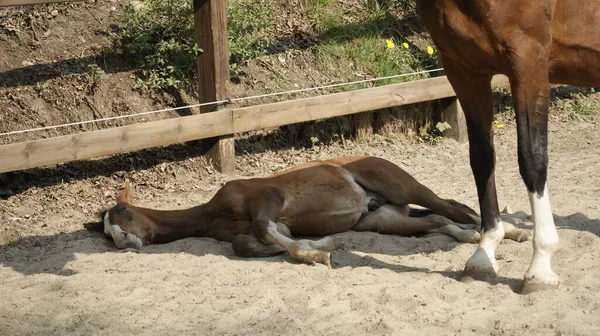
0,68,444,136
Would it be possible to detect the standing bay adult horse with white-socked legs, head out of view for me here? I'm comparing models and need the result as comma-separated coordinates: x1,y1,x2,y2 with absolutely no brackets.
417,0,600,292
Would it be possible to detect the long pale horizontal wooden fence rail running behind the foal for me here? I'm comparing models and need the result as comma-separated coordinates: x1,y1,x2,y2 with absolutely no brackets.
0,76,508,173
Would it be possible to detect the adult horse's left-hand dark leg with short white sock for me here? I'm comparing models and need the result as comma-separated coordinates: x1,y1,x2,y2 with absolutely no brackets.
443,58,504,281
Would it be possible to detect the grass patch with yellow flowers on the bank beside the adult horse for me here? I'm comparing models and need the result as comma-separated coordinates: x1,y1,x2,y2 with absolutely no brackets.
309,0,437,87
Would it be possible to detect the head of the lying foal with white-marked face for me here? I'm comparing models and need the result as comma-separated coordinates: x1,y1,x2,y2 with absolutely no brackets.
85,184,154,249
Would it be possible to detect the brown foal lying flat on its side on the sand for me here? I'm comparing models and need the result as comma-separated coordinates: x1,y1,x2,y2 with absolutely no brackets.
86,157,529,265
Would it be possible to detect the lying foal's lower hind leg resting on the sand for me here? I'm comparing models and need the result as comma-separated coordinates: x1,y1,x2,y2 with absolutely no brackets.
352,204,479,243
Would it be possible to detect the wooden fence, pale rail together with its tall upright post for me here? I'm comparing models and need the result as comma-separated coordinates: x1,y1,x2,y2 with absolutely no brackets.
0,0,508,173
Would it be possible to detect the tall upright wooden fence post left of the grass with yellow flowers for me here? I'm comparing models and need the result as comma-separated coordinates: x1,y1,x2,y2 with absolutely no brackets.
194,0,235,173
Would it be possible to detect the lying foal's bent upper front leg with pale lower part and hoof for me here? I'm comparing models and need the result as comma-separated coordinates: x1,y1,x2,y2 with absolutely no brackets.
246,188,338,266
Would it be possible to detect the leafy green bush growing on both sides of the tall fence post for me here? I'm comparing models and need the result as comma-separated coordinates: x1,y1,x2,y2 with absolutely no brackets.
110,0,274,91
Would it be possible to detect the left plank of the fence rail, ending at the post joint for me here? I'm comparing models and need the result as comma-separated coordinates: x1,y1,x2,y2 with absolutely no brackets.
0,110,233,173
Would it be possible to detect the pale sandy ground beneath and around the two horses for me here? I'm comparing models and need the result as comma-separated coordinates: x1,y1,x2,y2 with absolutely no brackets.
0,117,600,335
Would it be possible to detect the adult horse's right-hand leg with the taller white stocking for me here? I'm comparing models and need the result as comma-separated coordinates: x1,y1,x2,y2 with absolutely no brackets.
511,49,559,293
